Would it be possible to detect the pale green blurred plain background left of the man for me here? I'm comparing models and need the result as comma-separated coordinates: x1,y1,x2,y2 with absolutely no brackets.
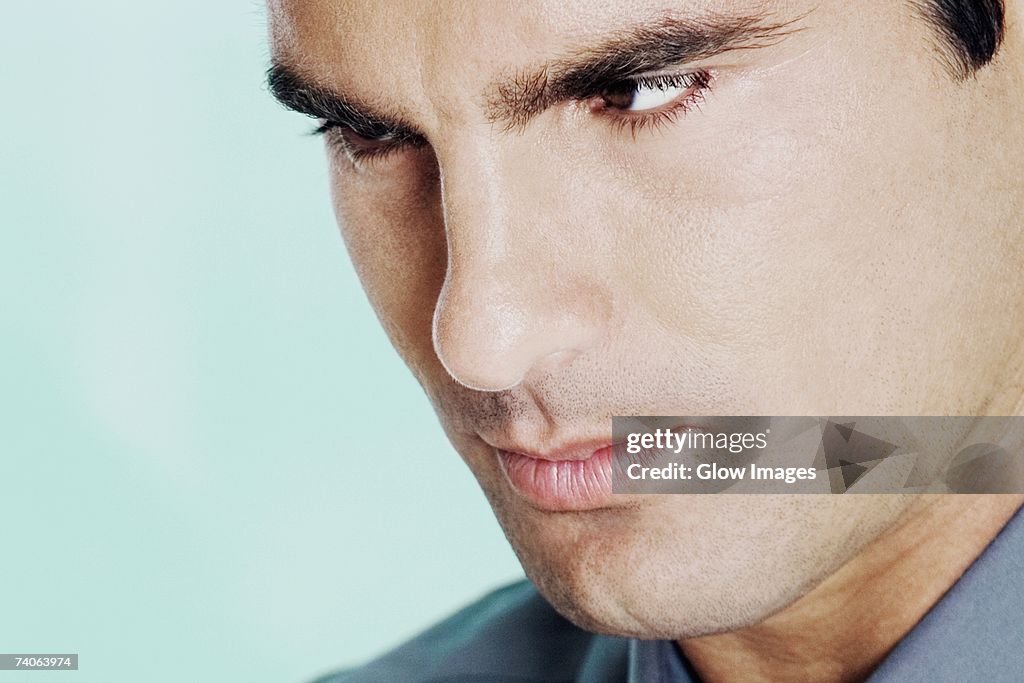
0,0,520,683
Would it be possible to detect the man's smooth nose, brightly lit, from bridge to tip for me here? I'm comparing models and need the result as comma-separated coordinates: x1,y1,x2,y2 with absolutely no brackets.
433,141,610,391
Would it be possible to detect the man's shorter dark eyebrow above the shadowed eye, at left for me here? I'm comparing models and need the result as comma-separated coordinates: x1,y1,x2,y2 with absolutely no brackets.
266,61,416,138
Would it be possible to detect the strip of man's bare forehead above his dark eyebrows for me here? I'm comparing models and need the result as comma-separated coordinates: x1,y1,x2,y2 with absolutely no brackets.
268,0,786,73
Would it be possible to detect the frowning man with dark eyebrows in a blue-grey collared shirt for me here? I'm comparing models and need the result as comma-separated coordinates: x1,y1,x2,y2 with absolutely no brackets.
269,0,1024,681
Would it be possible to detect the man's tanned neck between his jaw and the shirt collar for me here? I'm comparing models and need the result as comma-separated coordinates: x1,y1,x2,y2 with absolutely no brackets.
679,495,1024,683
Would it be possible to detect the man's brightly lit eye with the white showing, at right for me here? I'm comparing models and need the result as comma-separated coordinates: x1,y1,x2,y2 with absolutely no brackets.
598,72,710,115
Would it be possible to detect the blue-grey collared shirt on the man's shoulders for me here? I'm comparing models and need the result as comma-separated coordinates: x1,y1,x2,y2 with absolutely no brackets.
315,512,1024,683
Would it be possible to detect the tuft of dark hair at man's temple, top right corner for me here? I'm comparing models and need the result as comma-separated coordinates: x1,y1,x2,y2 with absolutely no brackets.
919,0,1006,78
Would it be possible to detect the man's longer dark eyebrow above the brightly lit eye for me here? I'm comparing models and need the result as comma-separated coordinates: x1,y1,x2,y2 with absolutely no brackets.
485,14,806,129
